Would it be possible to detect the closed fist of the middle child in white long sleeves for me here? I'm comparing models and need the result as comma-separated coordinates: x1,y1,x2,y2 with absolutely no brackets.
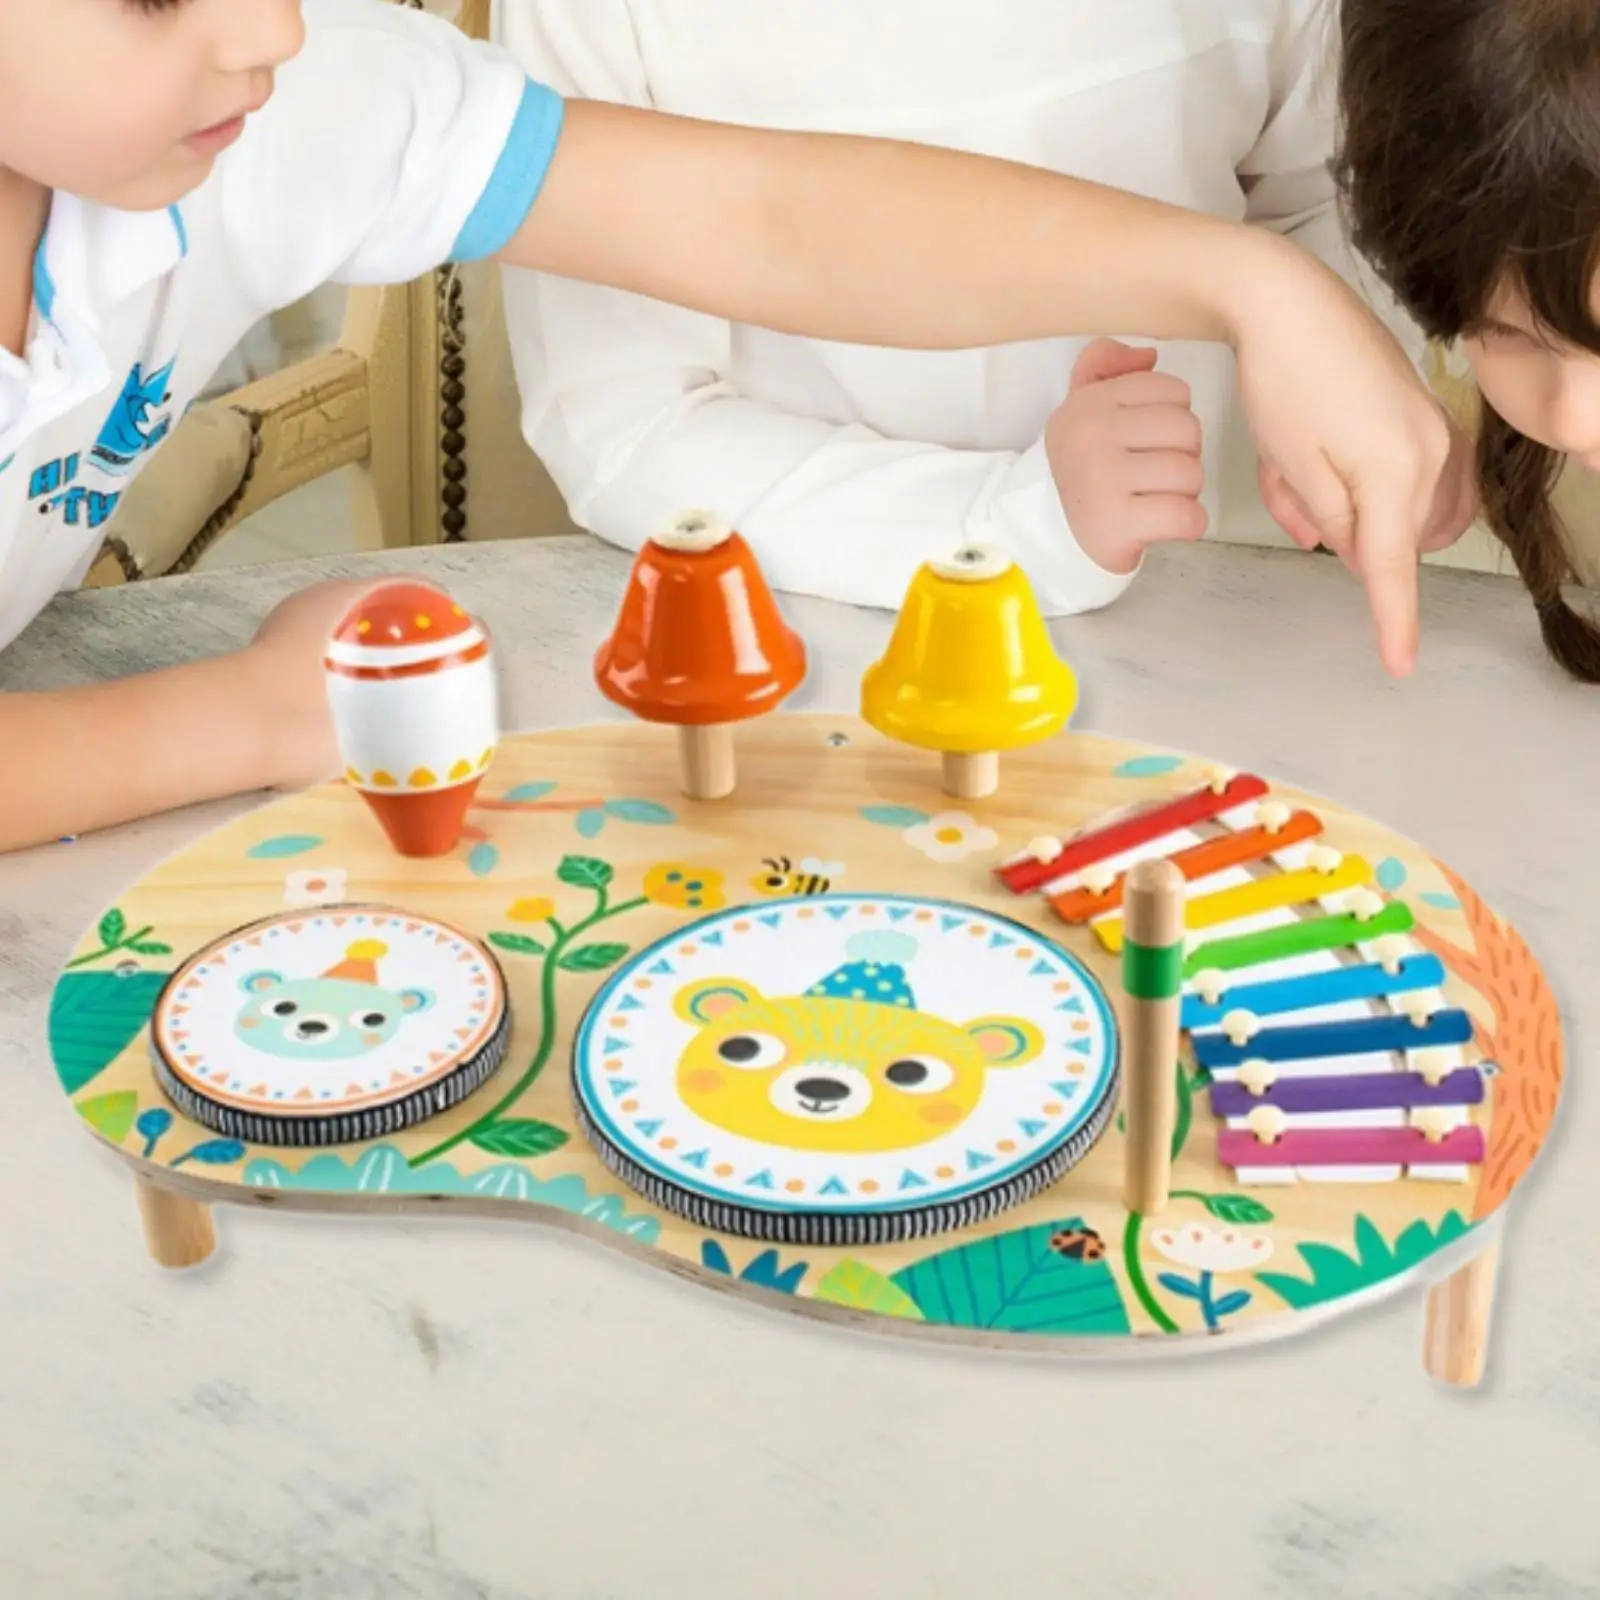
1045,339,1206,573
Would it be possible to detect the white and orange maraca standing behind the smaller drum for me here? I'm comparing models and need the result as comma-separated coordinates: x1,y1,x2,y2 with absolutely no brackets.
323,579,499,856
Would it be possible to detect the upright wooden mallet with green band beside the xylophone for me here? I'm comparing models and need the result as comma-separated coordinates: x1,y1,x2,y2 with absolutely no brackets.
1122,861,1184,1216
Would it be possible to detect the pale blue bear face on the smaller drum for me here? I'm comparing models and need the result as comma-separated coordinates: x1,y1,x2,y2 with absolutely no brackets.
234,973,434,1061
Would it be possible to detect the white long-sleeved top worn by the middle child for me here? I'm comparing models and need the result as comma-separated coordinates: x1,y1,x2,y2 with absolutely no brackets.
496,0,1419,614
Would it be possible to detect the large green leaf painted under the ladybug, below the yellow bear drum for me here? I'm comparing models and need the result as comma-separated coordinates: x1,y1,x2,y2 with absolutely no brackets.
891,1218,1131,1334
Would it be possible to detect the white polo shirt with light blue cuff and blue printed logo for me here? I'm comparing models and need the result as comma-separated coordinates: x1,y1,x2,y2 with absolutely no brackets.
0,0,562,646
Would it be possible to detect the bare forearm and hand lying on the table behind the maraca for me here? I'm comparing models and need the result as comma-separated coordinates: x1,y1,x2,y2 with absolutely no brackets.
0,582,370,851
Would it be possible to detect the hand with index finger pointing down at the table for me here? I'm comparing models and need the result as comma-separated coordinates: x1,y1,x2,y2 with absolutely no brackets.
1230,235,1461,677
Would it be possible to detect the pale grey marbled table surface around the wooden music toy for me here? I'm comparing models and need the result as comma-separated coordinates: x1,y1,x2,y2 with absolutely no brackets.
0,539,1600,1600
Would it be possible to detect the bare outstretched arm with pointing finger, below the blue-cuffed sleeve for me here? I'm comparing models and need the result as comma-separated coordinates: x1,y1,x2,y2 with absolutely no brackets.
499,102,1450,674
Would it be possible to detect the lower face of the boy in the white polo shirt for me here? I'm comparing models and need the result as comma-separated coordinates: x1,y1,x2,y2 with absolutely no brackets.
0,0,302,211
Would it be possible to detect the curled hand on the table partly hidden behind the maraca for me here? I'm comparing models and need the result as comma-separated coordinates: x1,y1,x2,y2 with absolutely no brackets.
245,579,376,789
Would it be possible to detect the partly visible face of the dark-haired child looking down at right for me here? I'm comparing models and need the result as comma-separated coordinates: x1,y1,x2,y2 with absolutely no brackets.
1462,280,1600,472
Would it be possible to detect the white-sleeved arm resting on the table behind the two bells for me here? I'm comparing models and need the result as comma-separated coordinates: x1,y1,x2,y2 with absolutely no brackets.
506,272,1131,616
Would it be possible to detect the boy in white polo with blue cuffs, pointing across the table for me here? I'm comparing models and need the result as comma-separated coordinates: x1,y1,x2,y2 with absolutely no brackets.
0,0,1448,848
